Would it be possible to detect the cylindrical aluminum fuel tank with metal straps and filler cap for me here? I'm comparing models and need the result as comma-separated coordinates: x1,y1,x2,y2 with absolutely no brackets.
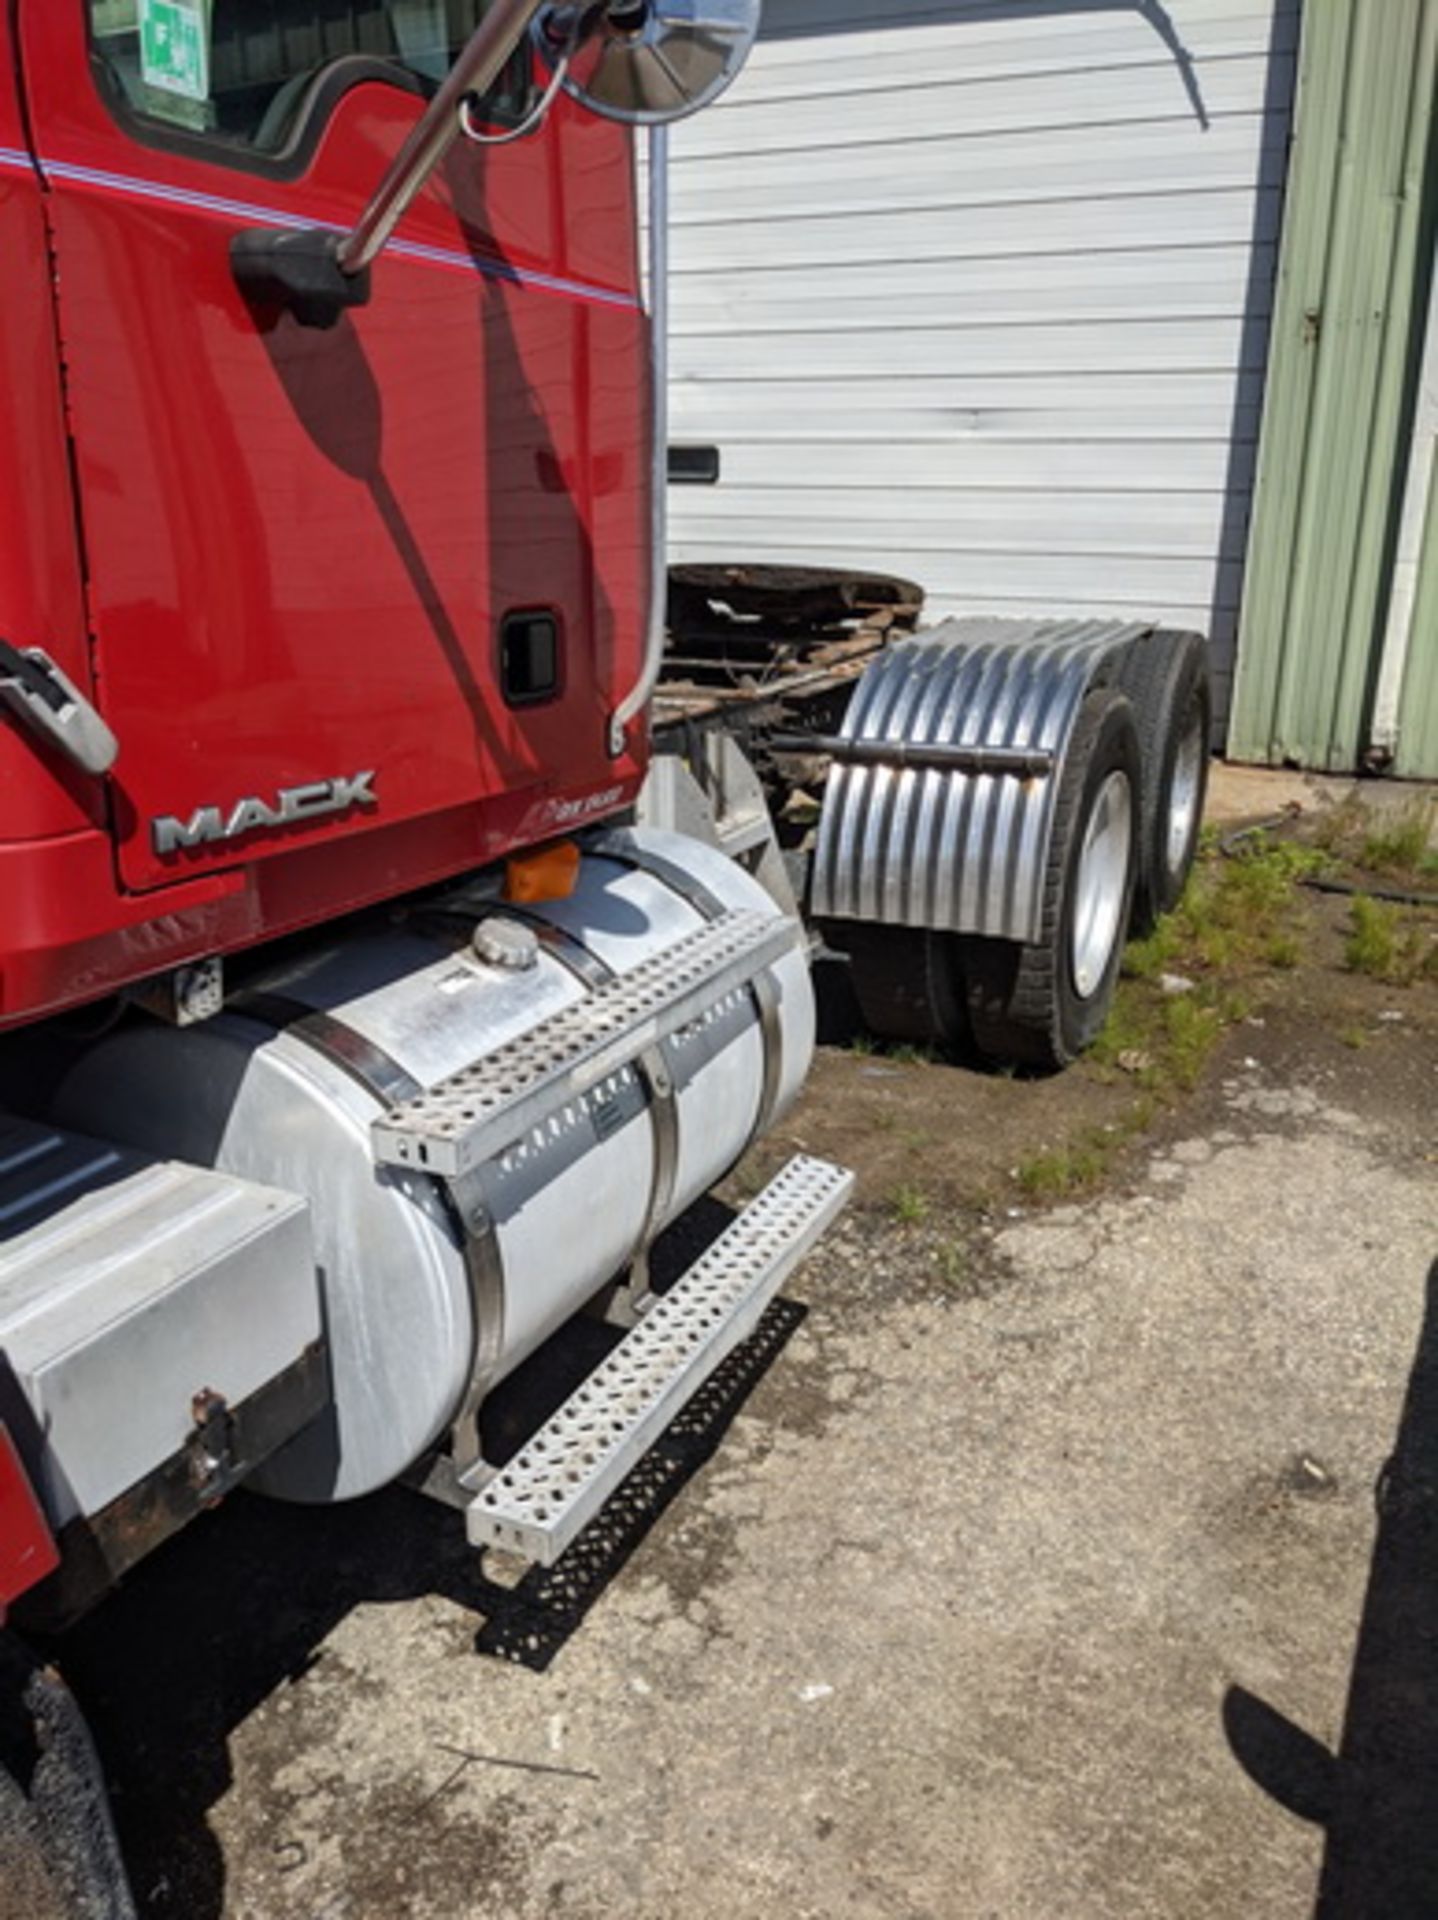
50,829,814,1501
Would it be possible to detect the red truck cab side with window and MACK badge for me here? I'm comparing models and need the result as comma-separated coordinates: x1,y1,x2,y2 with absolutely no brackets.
0,0,651,1027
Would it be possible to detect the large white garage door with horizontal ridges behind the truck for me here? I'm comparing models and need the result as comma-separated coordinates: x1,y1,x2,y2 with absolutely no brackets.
670,0,1298,721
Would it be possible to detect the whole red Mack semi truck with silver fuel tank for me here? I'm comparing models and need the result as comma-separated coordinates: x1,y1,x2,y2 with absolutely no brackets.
0,0,1208,1916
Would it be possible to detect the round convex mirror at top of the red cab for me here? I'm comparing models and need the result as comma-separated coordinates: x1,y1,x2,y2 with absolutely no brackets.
536,0,760,127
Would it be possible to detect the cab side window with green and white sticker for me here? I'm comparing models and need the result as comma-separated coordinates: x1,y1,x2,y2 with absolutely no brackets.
86,0,526,157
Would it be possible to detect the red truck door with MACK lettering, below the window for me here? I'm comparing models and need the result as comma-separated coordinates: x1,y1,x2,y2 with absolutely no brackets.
21,0,647,889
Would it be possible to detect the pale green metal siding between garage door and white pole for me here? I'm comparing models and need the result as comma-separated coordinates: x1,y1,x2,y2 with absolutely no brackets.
1229,0,1438,770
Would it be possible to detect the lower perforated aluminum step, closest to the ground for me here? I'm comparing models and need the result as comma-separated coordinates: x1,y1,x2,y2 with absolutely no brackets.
467,1154,854,1567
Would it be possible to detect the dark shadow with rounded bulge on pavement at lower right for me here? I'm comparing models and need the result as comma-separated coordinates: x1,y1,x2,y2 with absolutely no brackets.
1223,1261,1438,1920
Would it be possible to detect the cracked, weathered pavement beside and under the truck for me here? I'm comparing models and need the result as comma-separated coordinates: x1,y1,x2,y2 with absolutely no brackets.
61,975,1438,1920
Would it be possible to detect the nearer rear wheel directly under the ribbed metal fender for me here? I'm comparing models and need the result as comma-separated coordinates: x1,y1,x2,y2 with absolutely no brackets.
964,687,1140,1071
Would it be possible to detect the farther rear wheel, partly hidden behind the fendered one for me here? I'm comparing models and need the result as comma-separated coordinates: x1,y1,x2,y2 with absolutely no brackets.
1117,628,1213,933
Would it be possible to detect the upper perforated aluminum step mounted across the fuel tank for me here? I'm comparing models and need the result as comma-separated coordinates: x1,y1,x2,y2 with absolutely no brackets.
372,910,799,1179
